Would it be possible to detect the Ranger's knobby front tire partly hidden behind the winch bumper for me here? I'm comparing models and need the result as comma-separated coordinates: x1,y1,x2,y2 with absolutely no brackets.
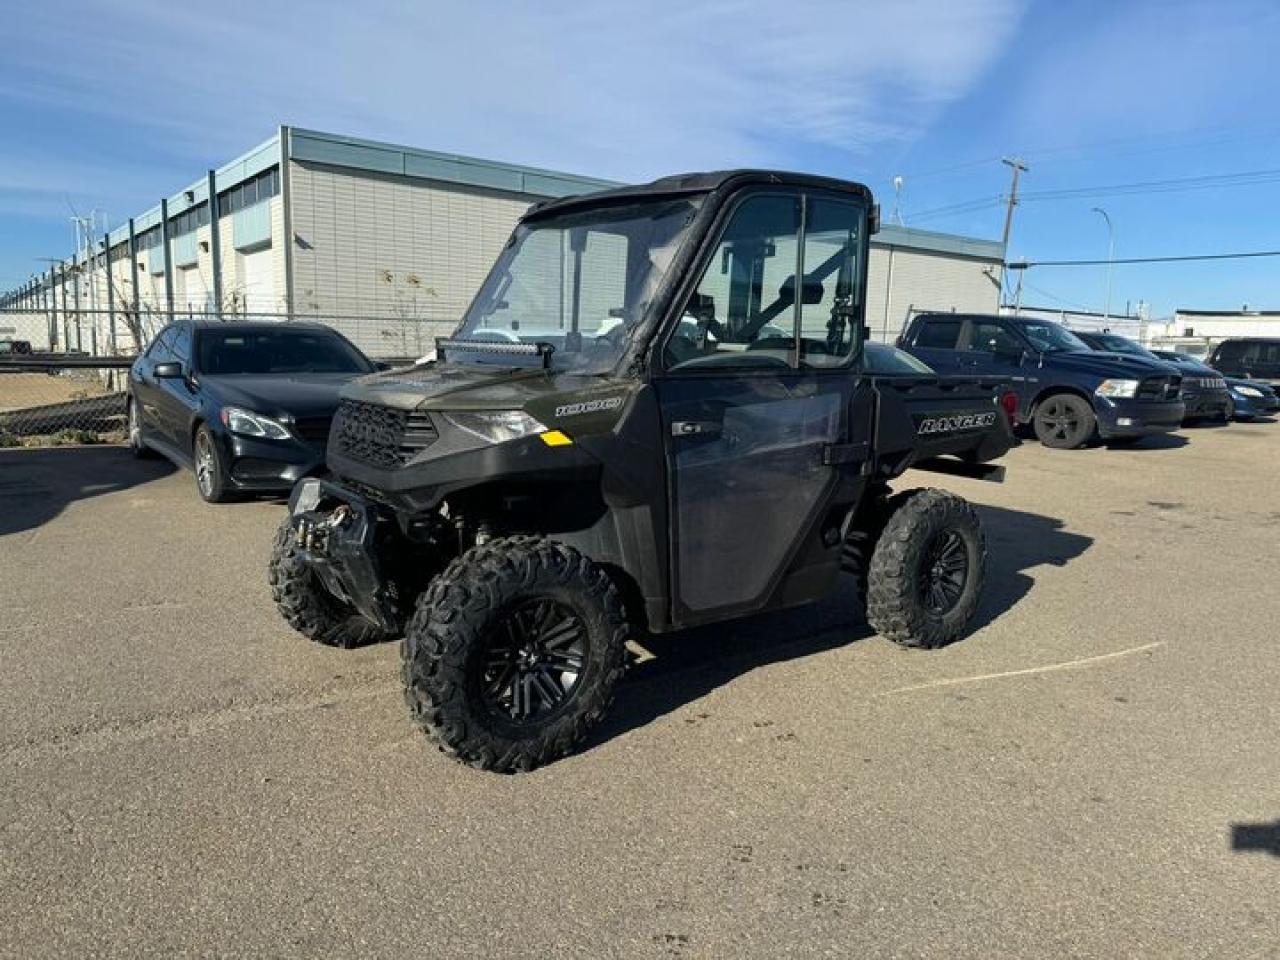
266,517,393,649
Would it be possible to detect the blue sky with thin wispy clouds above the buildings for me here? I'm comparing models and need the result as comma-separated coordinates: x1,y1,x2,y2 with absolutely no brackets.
0,0,1280,315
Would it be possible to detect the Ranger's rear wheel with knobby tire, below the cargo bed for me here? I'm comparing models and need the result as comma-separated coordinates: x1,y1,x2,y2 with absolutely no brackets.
867,489,987,649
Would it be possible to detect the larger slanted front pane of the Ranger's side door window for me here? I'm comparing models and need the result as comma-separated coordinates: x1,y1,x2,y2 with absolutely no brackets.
663,195,800,370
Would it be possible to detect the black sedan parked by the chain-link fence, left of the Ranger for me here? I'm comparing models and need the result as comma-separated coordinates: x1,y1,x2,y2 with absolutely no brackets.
127,320,379,503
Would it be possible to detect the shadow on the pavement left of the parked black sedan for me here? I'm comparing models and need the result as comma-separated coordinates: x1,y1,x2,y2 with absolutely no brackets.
0,445,175,536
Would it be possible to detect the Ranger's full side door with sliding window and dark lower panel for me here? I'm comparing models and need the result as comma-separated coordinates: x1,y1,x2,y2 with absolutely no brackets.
655,193,873,625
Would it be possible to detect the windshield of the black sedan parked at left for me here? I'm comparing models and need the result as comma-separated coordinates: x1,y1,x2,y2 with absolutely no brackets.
196,328,374,376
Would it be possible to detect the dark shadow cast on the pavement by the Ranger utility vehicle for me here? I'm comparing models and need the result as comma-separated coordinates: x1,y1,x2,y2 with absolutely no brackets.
586,506,1093,749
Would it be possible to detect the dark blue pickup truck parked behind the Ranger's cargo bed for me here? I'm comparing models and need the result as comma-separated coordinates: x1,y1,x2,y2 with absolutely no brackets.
899,314,1187,449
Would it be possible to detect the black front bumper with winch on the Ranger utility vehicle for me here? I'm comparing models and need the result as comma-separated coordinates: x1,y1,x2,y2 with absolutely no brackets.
289,477,403,632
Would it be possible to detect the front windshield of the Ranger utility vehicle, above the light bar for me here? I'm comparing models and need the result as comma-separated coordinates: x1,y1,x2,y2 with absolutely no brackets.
447,197,700,374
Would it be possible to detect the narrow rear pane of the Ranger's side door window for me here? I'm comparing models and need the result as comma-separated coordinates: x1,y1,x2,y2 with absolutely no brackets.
800,197,867,367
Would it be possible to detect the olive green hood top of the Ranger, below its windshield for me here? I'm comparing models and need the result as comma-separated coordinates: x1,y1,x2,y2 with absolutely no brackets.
342,361,608,410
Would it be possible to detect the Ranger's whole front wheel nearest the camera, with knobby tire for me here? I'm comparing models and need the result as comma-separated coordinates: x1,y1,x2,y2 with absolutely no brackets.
401,536,627,773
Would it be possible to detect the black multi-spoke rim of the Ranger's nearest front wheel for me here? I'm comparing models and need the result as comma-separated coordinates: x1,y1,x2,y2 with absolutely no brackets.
479,599,590,724
